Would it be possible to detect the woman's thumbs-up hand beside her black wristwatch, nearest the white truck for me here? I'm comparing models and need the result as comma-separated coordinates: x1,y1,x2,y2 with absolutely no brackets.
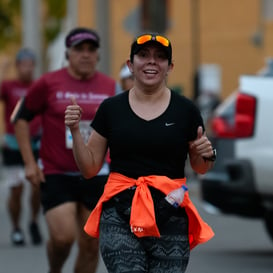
189,126,213,157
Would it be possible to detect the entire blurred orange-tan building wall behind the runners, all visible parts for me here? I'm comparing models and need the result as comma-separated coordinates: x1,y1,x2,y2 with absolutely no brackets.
78,0,273,98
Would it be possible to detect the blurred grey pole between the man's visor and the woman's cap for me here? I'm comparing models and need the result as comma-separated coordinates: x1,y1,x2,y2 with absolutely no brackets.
96,0,110,75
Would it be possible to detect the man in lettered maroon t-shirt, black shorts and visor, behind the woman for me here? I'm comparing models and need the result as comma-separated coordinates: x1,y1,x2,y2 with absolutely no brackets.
14,28,116,273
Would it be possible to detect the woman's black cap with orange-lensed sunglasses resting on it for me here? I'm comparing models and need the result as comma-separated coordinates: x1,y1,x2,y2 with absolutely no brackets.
130,32,172,64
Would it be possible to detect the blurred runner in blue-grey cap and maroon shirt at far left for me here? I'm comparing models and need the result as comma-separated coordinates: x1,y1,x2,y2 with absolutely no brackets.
0,48,41,245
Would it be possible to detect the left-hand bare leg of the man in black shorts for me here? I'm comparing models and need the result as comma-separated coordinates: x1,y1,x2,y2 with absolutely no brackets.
46,202,77,273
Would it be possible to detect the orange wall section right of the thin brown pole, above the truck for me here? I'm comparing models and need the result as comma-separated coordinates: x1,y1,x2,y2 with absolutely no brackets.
200,0,264,97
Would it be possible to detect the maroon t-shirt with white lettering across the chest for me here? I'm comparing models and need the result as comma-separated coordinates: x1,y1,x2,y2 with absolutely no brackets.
25,68,116,174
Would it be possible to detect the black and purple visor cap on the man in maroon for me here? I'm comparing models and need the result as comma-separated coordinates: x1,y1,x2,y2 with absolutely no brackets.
65,27,100,48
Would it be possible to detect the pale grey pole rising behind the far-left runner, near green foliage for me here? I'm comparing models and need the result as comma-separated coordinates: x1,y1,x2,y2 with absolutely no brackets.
21,0,43,77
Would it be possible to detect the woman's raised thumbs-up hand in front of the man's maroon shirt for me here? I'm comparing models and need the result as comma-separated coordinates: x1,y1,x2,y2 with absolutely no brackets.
64,96,83,130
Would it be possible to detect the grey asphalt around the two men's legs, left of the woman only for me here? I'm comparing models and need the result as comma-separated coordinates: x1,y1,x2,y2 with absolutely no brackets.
0,172,107,273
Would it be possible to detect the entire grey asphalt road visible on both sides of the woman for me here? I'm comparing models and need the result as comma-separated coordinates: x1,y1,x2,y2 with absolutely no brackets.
0,173,273,273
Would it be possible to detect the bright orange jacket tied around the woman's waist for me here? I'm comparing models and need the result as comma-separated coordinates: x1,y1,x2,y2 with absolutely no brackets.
84,173,214,249
